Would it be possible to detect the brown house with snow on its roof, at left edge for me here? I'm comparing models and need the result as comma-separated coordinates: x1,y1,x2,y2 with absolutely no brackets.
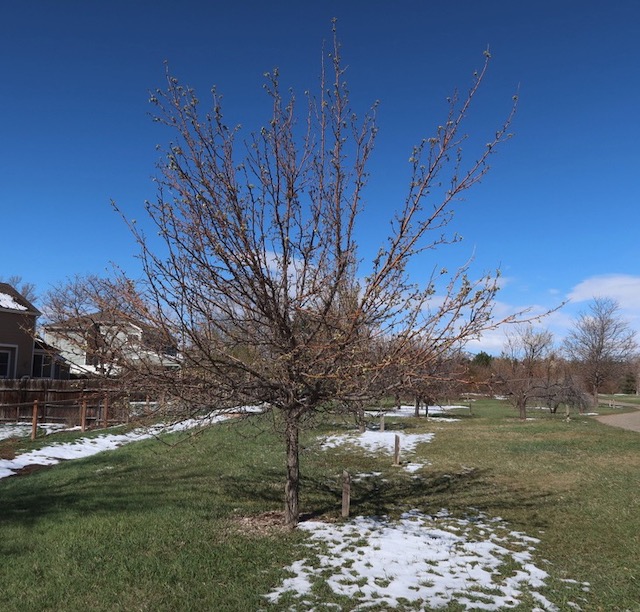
0,283,69,379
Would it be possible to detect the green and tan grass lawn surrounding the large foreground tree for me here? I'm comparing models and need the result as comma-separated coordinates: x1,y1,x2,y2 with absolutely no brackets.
0,400,640,612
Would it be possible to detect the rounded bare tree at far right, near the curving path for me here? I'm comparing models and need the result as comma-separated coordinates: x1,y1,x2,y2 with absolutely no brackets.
564,297,638,406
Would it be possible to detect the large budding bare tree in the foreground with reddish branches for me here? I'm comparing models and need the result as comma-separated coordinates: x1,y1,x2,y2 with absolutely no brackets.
99,29,515,526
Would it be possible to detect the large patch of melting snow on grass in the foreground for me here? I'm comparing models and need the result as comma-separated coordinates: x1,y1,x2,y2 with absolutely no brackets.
267,510,592,611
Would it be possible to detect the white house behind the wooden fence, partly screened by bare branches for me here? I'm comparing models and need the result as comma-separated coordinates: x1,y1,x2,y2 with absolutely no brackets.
43,311,180,376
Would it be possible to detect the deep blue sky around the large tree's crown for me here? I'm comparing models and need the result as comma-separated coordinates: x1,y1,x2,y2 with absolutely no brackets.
0,0,640,353
